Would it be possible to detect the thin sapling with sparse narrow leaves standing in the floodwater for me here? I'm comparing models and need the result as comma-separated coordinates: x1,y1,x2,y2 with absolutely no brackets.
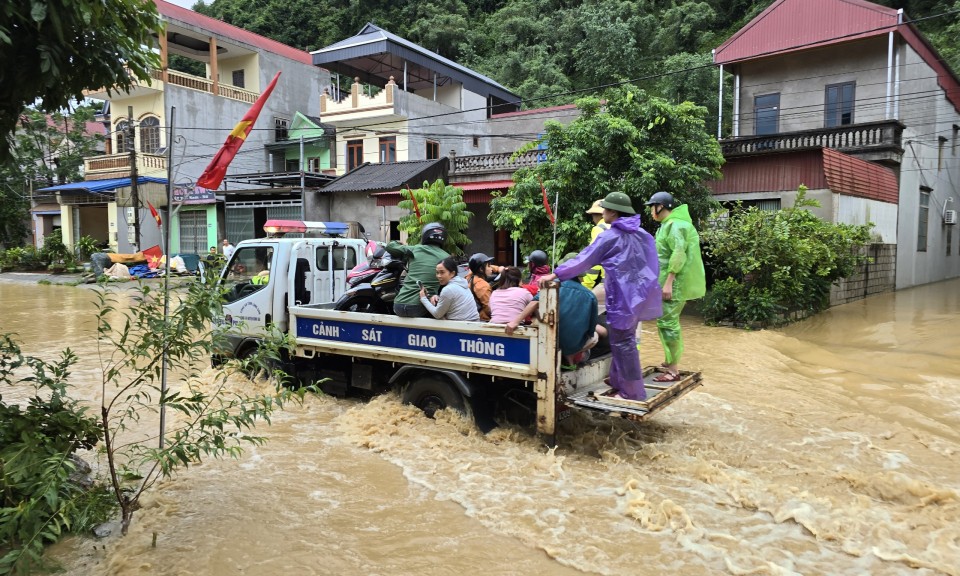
97,281,313,534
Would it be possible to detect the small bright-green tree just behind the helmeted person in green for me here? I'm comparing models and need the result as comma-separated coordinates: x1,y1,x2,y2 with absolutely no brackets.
398,180,473,254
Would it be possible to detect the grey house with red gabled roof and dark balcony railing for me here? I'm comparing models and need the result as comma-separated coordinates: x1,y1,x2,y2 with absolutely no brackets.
713,0,960,302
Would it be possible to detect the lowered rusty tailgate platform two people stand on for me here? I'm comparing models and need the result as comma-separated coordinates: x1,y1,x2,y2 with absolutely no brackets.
565,361,703,421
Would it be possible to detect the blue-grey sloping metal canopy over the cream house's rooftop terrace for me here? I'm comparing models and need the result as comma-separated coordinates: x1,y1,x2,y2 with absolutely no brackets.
311,22,520,104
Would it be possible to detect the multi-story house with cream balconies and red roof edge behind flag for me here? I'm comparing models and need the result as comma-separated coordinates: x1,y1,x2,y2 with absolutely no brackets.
52,0,329,254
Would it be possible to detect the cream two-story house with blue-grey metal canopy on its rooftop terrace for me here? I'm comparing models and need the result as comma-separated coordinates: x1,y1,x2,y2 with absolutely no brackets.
306,24,576,262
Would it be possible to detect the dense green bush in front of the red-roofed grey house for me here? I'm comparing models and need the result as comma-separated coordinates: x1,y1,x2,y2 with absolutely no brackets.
701,186,872,326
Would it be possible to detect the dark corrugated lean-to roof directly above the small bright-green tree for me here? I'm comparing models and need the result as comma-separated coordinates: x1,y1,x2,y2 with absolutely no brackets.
320,157,449,192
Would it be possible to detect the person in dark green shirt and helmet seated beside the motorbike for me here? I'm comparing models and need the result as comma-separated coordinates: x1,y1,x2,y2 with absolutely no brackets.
384,222,450,318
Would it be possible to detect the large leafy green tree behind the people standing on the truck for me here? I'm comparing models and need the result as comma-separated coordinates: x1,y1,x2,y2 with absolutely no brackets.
490,86,723,262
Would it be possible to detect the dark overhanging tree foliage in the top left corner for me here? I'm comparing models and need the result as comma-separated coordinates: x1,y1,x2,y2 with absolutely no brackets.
0,0,162,161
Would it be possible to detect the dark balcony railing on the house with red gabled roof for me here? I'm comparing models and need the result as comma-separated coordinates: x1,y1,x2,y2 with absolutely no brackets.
720,120,904,157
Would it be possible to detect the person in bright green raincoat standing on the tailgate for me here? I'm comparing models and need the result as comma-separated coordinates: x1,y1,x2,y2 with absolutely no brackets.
646,192,707,382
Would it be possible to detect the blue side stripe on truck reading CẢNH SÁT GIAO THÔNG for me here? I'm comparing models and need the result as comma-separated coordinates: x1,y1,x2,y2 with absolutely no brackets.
297,318,530,364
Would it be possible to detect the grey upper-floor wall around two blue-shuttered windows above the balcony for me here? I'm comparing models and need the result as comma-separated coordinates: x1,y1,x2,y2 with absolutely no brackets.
738,36,892,136
